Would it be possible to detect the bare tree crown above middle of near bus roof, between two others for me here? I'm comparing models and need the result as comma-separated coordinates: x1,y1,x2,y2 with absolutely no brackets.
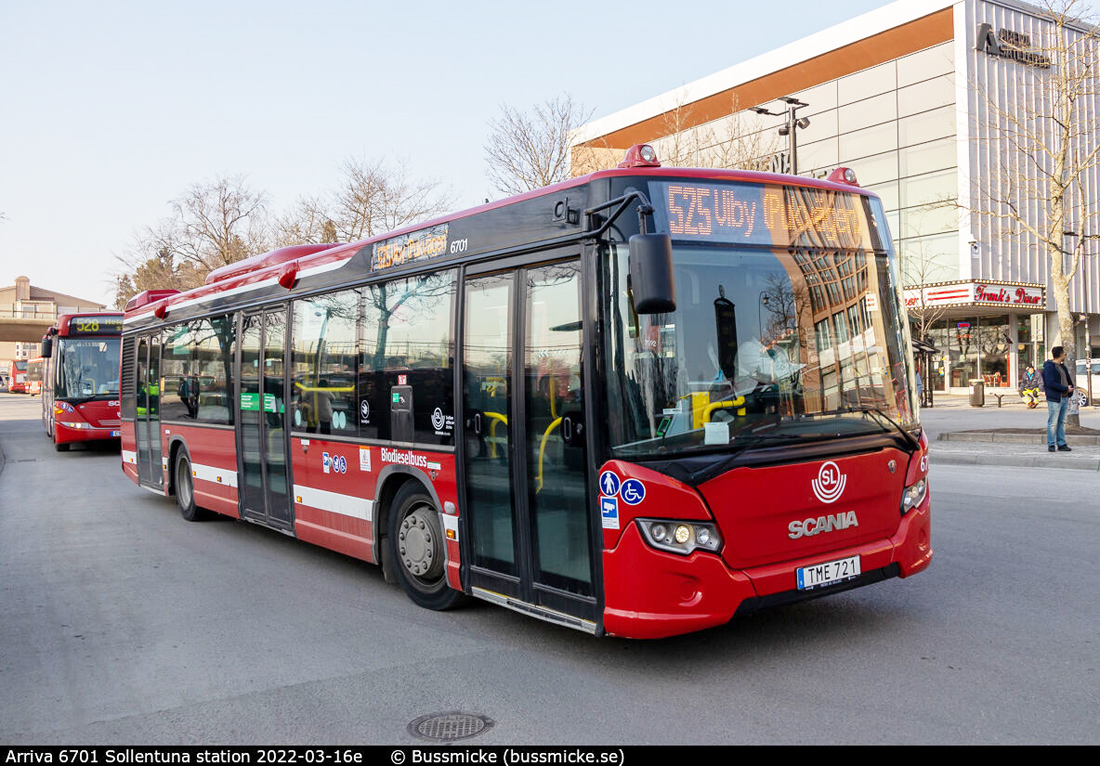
275,158,452,244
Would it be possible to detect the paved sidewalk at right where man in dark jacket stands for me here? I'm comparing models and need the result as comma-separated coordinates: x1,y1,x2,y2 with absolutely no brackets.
921,394,1100,471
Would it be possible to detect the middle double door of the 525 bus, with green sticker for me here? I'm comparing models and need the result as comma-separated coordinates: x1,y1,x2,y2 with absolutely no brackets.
237,306,292,529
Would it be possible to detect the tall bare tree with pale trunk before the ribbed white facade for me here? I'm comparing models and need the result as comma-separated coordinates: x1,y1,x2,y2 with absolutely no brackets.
971,0,1100,362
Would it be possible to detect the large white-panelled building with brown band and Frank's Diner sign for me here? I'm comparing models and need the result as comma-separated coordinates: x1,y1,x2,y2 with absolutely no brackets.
573,0,1100,393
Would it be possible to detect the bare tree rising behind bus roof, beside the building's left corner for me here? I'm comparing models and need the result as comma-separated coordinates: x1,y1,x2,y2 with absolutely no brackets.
485,94,594,195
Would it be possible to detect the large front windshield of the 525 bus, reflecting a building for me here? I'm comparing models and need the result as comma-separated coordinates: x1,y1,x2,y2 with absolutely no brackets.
604,237,917,458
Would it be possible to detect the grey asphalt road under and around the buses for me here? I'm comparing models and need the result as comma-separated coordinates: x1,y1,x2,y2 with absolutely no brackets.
0,394,1100,745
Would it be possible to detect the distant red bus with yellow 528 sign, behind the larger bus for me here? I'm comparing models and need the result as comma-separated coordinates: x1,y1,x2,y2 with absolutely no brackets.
42,311,122,452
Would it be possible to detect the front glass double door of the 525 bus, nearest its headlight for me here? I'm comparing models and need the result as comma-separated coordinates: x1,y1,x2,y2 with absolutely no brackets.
462,260,597,627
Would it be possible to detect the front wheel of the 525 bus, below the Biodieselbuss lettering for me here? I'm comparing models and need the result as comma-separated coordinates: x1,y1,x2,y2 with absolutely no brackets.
389,482,462,612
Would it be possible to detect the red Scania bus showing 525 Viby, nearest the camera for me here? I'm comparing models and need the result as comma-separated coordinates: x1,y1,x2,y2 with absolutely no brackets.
121,147,932,638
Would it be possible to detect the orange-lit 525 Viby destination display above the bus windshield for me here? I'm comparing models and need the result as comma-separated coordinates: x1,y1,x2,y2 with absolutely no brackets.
651,182,873,250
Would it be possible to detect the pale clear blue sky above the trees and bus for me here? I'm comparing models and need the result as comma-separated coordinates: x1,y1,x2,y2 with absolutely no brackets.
0,0,887,305
